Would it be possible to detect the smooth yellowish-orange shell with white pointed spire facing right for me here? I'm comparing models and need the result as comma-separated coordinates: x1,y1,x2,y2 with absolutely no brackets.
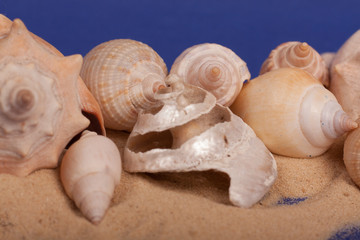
230,68,357,158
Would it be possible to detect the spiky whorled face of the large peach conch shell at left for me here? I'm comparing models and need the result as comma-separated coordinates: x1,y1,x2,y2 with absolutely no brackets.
0,17,89,176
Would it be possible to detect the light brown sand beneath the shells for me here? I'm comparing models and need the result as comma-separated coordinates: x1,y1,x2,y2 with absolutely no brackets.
0,131,360,240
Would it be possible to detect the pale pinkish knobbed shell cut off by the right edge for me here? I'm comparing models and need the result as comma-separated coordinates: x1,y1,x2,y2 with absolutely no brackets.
330,30,360,119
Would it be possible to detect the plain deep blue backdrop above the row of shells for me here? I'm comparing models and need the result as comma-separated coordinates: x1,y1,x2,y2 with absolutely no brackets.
0,0,360,77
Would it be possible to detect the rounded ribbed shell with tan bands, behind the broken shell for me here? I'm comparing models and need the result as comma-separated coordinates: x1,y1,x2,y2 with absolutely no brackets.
80,39,167,131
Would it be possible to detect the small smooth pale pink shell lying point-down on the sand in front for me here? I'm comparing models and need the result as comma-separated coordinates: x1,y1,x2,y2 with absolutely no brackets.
60,130,121,224
